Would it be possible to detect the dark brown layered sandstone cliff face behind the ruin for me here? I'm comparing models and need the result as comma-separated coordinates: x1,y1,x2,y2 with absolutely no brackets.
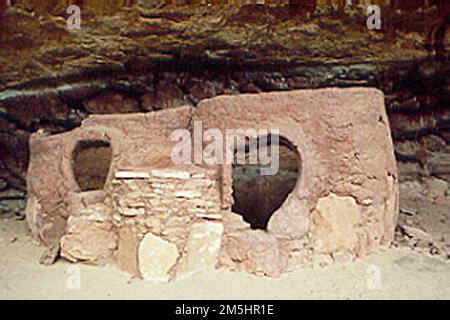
0,2,450,212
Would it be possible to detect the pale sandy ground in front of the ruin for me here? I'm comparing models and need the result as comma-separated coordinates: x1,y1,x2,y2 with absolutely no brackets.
0,218,450,299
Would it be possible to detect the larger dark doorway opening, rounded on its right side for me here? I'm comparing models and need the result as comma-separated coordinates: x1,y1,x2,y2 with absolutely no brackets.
232,136,301,230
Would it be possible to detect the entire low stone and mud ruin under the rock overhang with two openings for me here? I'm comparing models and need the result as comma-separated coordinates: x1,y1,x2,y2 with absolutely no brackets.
26,88,399,281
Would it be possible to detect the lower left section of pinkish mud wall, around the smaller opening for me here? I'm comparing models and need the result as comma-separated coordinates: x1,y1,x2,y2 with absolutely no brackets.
27,108,190,245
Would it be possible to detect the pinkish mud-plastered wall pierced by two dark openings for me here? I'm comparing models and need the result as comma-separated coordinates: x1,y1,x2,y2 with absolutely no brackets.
27,88,398,278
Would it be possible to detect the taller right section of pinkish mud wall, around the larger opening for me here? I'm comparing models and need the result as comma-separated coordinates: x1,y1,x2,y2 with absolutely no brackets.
193,88,398,273
